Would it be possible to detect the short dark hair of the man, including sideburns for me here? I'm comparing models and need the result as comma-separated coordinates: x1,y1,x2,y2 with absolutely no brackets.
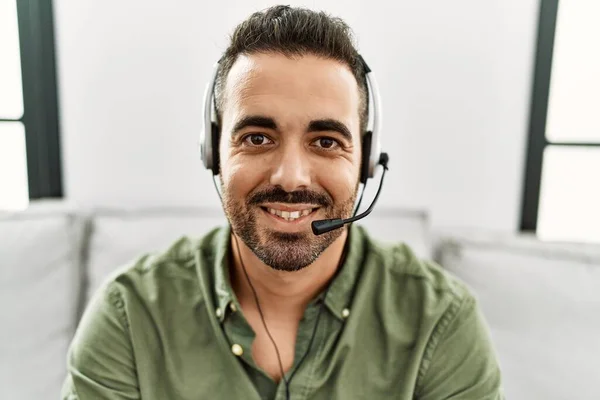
215,5,369,134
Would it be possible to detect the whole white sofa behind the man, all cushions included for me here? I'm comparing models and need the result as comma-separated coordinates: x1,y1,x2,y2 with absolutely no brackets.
0,203,600,400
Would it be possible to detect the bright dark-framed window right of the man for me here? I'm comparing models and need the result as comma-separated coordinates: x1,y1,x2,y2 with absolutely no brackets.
521,0,600,242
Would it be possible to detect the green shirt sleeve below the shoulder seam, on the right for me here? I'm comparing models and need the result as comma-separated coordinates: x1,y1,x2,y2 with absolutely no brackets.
416,295,504,400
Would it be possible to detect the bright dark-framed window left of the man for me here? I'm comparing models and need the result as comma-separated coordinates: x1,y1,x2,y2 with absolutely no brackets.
0,0,62,210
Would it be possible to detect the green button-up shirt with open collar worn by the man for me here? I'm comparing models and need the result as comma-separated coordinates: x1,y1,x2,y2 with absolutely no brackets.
62,226,503,400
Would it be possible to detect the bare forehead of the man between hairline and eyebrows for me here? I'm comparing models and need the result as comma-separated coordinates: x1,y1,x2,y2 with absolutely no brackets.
223,53,360,130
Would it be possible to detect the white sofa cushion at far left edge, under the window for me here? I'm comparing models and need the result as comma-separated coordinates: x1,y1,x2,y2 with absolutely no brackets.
0,205,84,400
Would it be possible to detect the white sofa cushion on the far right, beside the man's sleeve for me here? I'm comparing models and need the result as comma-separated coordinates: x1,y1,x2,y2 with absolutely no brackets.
438,233,600,400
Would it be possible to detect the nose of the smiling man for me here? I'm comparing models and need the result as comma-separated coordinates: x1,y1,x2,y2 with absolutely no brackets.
270,143,311,192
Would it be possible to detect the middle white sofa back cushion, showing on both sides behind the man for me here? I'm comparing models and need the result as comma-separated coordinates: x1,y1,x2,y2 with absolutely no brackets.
88,208,430,298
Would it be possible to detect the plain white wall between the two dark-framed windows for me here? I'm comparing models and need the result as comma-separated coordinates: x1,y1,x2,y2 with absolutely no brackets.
54,0,539,230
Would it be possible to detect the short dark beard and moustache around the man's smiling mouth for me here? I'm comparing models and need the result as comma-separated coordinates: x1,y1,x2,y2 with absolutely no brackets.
221,182,358,271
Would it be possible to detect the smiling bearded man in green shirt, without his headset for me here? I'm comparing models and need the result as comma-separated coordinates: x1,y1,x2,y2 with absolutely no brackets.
63,6,502,400
